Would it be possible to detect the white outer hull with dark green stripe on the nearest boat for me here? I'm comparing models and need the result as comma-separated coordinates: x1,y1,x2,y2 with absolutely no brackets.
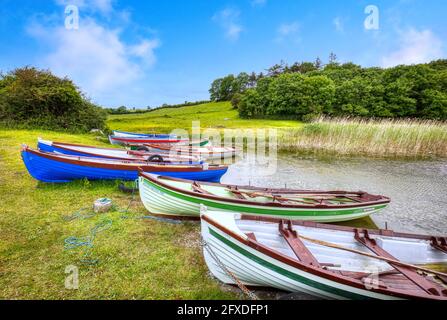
201,215,399,300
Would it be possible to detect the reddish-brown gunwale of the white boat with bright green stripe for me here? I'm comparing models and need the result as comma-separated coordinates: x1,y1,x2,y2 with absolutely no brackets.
139,172,391,209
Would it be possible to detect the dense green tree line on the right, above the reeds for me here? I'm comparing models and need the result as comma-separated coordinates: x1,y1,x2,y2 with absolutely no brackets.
209,54,447,120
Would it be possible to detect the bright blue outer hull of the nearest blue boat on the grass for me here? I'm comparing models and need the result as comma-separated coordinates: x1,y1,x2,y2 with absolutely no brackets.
22,149,227,183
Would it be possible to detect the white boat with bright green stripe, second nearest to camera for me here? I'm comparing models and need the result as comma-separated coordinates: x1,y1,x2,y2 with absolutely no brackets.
139,172,390,222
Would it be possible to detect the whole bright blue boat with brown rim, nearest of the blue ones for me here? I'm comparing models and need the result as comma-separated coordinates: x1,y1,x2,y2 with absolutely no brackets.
21,146,228,183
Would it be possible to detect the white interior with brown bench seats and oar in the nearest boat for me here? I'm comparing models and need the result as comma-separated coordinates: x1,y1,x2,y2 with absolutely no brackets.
230,217,447,298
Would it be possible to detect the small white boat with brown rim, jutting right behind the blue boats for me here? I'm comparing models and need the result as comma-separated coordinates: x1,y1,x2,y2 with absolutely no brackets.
144,143,239,160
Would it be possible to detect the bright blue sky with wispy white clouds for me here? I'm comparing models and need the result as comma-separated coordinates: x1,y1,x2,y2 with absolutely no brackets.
0,0,447,107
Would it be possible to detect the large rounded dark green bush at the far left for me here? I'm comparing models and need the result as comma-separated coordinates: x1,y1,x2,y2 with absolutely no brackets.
0,67,106,132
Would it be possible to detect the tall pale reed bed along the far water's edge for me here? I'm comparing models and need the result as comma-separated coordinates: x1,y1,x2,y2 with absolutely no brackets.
278,118,447,158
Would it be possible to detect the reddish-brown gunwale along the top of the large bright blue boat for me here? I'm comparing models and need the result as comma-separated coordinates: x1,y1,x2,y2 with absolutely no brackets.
22,146,228,172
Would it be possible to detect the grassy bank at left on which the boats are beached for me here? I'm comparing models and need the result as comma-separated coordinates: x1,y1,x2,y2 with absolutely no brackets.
0,130,238,299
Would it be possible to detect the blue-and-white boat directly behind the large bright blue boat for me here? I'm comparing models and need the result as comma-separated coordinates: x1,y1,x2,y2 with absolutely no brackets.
37,138,200,164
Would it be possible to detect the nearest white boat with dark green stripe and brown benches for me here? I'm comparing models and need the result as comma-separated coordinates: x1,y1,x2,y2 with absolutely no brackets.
201,207,447,300
